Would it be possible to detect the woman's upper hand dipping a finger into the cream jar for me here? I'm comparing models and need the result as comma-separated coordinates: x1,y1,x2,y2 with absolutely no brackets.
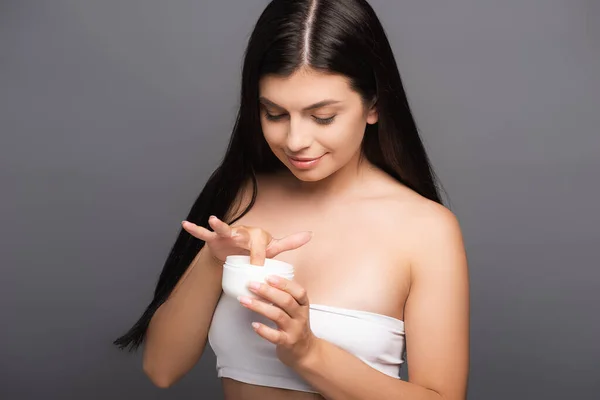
182,216,312,265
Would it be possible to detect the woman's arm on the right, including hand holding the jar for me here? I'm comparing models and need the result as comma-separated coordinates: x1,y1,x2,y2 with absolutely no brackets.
241,208,469,400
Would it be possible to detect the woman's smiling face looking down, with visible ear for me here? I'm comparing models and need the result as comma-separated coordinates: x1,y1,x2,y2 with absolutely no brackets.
259,68,377,181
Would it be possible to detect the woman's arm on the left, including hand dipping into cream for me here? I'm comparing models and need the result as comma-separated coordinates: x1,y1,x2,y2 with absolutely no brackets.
143,177,311,388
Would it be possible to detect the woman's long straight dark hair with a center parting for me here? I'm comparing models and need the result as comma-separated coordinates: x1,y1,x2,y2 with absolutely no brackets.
114,0,442,350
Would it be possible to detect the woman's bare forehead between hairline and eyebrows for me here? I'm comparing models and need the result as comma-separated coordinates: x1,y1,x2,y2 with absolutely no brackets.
259,69,360,110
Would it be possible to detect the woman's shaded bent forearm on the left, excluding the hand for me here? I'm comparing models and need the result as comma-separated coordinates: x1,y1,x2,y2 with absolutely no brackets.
143,246,223,388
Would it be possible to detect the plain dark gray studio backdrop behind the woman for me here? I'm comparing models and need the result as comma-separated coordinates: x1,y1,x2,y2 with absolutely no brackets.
0,0,600,400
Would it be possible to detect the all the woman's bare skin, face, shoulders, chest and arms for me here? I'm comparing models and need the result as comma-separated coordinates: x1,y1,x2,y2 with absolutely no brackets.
144,69,469,400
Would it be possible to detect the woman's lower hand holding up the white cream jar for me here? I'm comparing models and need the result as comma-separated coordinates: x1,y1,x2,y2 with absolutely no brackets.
239,276,317,367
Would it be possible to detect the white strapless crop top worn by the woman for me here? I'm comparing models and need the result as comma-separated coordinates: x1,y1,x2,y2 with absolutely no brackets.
208,294,404,393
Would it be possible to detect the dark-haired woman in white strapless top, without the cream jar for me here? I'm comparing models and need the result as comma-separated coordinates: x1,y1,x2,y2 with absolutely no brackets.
115,0,469,400
